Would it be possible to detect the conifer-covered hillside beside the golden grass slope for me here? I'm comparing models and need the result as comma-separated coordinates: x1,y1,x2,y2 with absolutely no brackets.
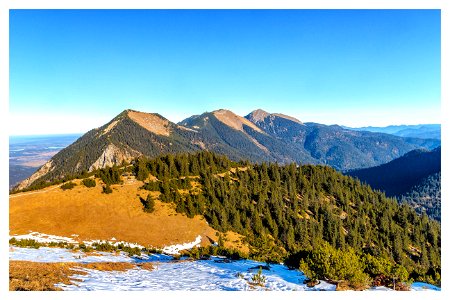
134,152,441,286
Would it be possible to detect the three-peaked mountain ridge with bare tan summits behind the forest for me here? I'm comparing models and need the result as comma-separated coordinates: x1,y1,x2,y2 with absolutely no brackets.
16,109,440,189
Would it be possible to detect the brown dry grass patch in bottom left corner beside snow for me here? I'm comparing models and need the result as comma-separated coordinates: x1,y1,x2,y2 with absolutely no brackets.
9,261,153,291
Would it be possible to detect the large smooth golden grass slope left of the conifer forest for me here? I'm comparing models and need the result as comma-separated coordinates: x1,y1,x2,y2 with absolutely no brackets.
9,180,217,247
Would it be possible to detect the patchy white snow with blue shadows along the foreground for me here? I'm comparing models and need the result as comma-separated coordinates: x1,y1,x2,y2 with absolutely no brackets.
9,247,440,291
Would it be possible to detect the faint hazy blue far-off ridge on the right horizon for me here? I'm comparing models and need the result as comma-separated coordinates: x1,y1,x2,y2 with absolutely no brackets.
344,124,441,140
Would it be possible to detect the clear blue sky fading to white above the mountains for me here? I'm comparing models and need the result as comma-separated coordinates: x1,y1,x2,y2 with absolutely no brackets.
9,10,441,135
